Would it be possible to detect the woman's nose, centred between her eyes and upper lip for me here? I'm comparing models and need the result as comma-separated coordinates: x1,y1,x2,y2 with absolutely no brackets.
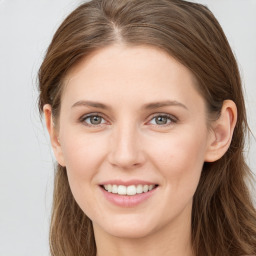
108,124,145,169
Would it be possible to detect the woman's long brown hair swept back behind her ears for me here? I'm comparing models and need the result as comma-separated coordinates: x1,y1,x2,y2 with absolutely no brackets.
39,0,256,256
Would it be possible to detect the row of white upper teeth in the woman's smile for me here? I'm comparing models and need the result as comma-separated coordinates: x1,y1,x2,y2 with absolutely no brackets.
104,184,156,196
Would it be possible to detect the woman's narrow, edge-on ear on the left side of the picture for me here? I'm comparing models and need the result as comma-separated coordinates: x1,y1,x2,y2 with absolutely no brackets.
43,104,65,166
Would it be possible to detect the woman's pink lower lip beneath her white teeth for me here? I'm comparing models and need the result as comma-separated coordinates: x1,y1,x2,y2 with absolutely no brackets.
100,187,157,207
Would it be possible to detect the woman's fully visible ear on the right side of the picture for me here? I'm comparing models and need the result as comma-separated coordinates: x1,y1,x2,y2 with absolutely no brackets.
205,100,237,162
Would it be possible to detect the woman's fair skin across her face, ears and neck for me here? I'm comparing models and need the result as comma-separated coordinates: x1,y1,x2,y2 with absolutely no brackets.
44,45,236,256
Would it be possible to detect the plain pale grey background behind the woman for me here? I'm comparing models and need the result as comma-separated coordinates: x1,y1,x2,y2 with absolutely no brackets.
0,0,256,256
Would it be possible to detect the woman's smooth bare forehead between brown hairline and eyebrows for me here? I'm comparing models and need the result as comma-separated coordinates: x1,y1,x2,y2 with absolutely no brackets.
62,45,205,111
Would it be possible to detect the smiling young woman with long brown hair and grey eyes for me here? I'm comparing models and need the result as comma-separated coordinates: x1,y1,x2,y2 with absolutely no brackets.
39,0,256,256
